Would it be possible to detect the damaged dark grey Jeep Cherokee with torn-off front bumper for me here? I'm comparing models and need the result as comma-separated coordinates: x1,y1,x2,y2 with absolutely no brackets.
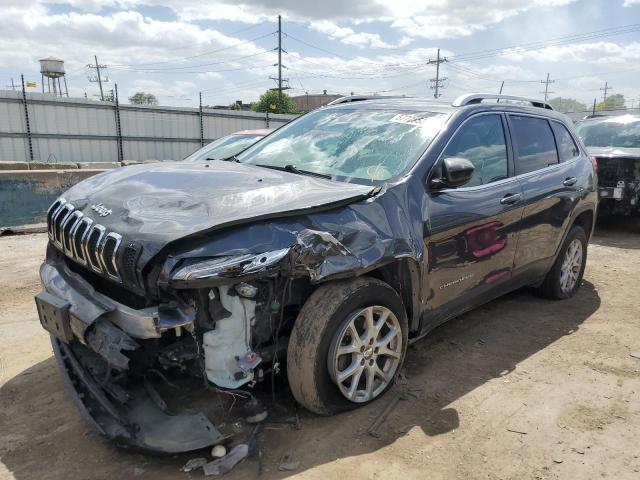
36,94,597,452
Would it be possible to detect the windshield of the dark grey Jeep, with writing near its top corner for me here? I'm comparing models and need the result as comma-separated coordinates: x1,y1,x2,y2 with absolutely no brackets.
238,108,448,183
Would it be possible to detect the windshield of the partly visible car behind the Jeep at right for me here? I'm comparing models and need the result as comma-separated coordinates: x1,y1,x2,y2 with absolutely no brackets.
576,115,640,148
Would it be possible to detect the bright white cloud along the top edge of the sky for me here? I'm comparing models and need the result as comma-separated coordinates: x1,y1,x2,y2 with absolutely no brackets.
35,0,576,40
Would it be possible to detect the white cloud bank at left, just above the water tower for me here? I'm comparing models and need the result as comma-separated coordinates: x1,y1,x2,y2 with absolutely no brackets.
0,5,272,70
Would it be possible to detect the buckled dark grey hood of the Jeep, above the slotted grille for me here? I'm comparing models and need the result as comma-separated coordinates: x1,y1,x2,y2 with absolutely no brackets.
63,161,374,260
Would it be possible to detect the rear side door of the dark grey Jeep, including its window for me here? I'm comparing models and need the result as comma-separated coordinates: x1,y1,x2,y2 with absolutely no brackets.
508,114,581,281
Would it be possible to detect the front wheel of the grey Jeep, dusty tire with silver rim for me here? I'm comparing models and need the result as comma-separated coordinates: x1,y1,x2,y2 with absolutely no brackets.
287,277,408,415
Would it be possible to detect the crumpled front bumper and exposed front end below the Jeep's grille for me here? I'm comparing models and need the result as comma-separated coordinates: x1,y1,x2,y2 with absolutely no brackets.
36,246,308,453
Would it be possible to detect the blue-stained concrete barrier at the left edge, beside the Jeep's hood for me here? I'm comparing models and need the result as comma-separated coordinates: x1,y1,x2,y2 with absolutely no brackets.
0,167,106,229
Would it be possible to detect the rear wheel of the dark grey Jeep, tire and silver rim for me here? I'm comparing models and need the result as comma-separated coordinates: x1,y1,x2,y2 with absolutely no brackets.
538,225,587,300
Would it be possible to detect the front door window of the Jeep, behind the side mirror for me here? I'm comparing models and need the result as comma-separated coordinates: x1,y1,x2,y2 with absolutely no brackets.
442,114,508,187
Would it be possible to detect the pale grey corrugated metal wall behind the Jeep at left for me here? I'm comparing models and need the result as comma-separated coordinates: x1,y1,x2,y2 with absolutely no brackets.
0,91,295,162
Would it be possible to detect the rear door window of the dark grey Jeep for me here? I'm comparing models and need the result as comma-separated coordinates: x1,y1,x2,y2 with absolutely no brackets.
509,115,558,175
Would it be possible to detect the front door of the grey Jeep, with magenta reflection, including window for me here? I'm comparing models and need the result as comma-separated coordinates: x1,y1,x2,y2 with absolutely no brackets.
425,113,522,329
